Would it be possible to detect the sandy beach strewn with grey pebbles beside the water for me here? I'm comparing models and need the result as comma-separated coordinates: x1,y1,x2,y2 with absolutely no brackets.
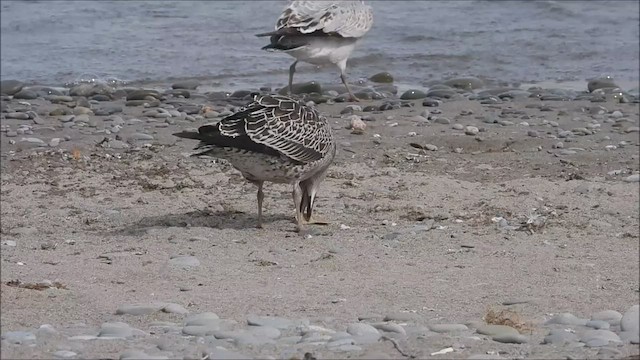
0,78,640,359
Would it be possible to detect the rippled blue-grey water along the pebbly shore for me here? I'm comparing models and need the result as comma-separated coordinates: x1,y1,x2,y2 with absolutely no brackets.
0,0,640,89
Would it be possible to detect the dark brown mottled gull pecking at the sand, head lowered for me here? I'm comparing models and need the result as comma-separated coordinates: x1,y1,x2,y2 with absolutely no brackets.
174,95,336,231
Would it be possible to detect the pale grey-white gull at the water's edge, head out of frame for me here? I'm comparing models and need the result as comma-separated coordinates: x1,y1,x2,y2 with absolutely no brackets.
256,0,373,101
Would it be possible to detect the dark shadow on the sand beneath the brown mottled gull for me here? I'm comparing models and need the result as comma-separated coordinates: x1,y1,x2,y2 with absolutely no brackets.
116,209,293,235
